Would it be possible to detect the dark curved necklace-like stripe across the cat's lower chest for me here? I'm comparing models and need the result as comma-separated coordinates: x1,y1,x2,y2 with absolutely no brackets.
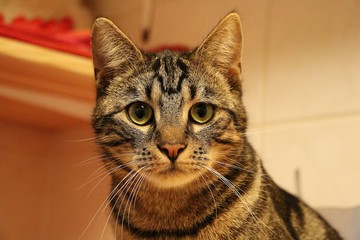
111,149,256,238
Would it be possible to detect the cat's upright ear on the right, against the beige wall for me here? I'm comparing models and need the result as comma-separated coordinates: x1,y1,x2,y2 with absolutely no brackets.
195,12,243,88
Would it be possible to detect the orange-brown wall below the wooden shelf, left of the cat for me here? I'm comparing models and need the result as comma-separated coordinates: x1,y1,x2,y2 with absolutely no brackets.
0,123,111,240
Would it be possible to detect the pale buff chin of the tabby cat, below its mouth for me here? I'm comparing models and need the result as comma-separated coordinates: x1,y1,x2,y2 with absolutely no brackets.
147,173,199,189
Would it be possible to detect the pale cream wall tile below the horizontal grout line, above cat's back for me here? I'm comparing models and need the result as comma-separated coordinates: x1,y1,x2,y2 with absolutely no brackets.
263,115,360,207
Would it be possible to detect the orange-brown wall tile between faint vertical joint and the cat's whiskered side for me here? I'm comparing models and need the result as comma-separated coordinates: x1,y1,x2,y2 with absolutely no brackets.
43,126,110,240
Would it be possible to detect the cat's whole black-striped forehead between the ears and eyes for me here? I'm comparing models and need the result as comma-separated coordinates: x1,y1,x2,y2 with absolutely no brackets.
107,51,230,113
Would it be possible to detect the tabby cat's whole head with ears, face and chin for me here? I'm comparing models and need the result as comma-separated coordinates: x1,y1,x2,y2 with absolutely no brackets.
92,13,246,188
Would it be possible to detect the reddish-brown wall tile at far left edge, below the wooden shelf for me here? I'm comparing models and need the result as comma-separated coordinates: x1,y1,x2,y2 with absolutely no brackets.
0,124,49,240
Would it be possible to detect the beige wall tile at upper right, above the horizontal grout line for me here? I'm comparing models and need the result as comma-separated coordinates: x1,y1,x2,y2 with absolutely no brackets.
264,0,360,122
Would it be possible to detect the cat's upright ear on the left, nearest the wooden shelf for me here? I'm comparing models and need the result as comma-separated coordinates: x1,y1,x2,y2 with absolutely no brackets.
91,17,143,83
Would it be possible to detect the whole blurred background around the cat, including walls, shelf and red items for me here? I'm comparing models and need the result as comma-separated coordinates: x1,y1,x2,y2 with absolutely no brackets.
0,0,360,240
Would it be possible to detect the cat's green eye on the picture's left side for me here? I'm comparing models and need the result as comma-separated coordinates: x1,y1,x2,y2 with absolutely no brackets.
128,102,153,126
